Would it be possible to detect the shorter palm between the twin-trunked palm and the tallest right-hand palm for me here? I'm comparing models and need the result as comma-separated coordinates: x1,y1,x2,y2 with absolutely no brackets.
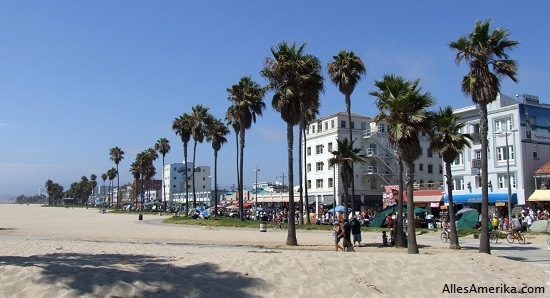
430,107,472,249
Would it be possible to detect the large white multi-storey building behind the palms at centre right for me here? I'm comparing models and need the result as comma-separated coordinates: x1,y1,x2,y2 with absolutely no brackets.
302,113,443,209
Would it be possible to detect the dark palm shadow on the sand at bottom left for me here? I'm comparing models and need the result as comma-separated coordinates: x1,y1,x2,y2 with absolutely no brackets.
0,253,267,297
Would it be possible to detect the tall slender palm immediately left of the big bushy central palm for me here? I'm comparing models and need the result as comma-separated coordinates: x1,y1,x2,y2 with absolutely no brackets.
227,77,266,221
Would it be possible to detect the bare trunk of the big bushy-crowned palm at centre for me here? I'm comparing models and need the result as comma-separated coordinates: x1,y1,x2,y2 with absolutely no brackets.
283,123,298,245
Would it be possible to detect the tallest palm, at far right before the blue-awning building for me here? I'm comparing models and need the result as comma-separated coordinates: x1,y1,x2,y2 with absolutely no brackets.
449,20,519,254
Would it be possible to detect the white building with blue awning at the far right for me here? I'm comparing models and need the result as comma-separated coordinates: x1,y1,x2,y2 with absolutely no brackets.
445,94,550,214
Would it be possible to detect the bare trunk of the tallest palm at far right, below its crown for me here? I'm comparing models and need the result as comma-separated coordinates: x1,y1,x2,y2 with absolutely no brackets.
479,102,491,254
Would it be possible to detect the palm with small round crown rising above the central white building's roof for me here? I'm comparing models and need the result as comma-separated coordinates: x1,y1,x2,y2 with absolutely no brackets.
327,50,367,211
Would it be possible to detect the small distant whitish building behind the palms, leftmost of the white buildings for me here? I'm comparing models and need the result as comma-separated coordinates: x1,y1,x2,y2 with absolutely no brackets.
162,162,213,206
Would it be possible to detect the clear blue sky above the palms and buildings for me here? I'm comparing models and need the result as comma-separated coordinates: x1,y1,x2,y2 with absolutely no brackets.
0,0,550,198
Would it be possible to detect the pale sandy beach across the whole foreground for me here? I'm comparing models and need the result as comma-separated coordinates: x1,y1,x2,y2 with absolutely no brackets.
0,205,550,297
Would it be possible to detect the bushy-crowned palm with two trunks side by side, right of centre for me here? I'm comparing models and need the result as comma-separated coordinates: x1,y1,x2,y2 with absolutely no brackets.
370,75,435,254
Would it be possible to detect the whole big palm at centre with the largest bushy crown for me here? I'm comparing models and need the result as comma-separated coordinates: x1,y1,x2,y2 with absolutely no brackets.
261,41,323,245
